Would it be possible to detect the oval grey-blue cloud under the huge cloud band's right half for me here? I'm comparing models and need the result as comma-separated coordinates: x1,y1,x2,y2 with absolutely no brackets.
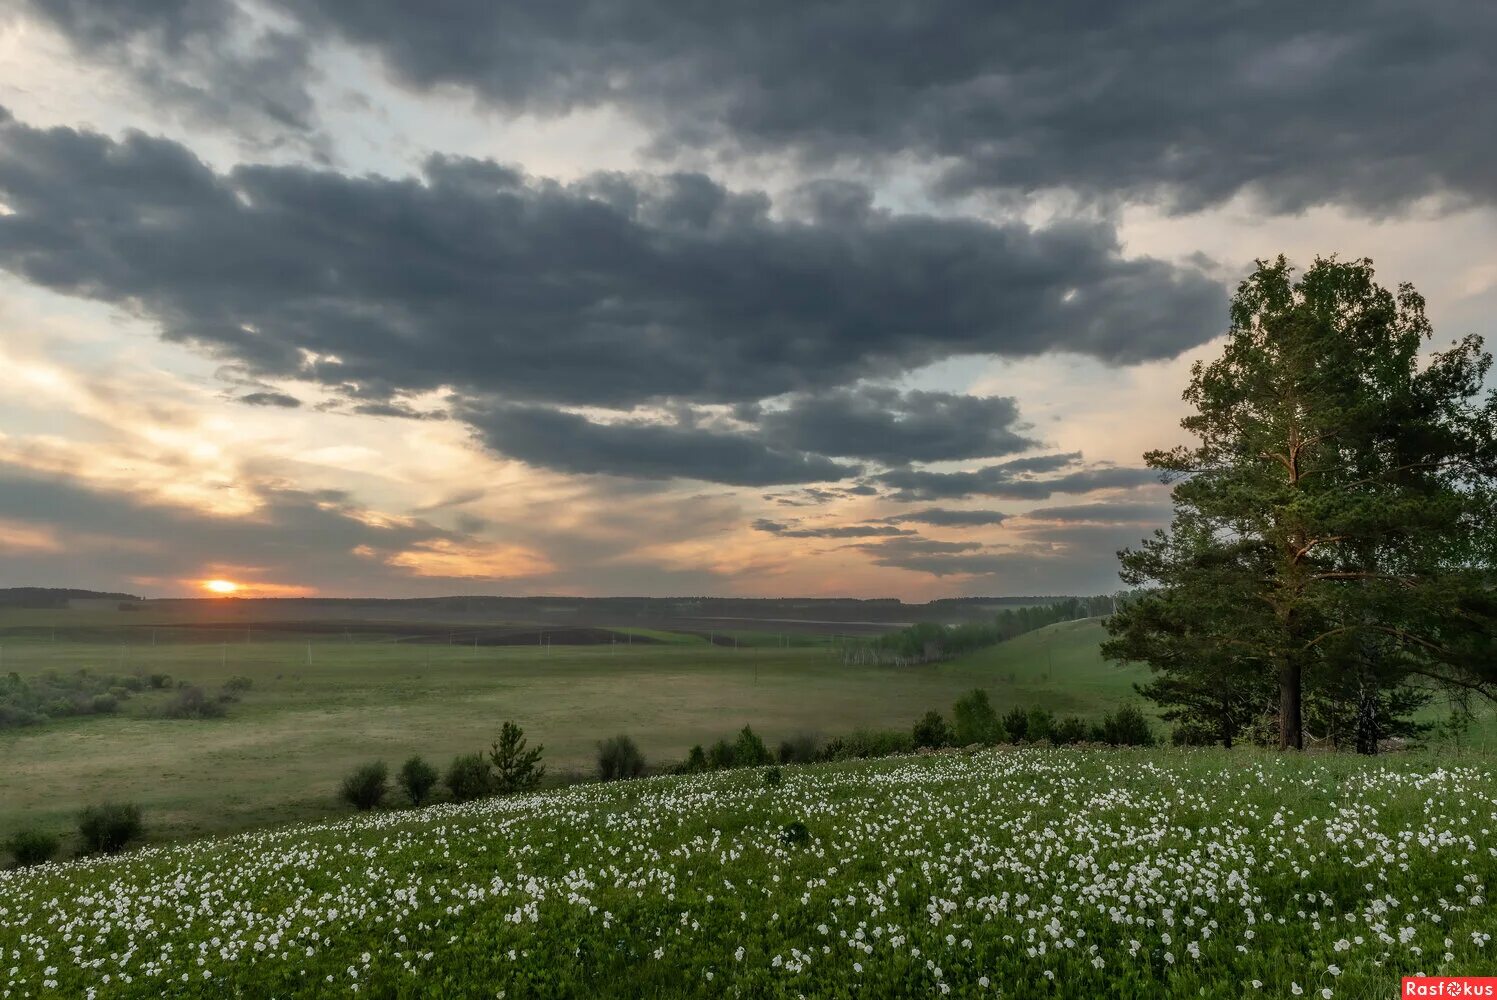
759,386,1037,464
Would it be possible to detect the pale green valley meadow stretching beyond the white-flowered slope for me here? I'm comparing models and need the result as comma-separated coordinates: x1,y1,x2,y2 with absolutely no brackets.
0,611,1142,838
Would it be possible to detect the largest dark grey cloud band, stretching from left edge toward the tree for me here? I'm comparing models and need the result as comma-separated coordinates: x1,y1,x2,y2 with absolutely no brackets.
0,121,1225,419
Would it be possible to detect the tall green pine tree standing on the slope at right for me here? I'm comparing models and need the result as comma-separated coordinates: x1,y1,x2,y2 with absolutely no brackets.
1103,257,1497,751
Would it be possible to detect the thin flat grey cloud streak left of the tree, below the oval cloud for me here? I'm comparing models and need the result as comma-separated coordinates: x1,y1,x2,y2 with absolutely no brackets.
874,454,1159,503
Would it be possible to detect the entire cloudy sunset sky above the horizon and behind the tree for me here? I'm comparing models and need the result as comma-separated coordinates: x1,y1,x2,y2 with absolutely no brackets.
0,0,1497,600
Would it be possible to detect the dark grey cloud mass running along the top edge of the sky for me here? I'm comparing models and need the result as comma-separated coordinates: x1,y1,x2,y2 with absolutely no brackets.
23,0,1497,213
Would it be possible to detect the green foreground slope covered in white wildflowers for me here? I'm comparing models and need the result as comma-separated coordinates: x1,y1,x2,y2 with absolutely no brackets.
0,750,1497,997
